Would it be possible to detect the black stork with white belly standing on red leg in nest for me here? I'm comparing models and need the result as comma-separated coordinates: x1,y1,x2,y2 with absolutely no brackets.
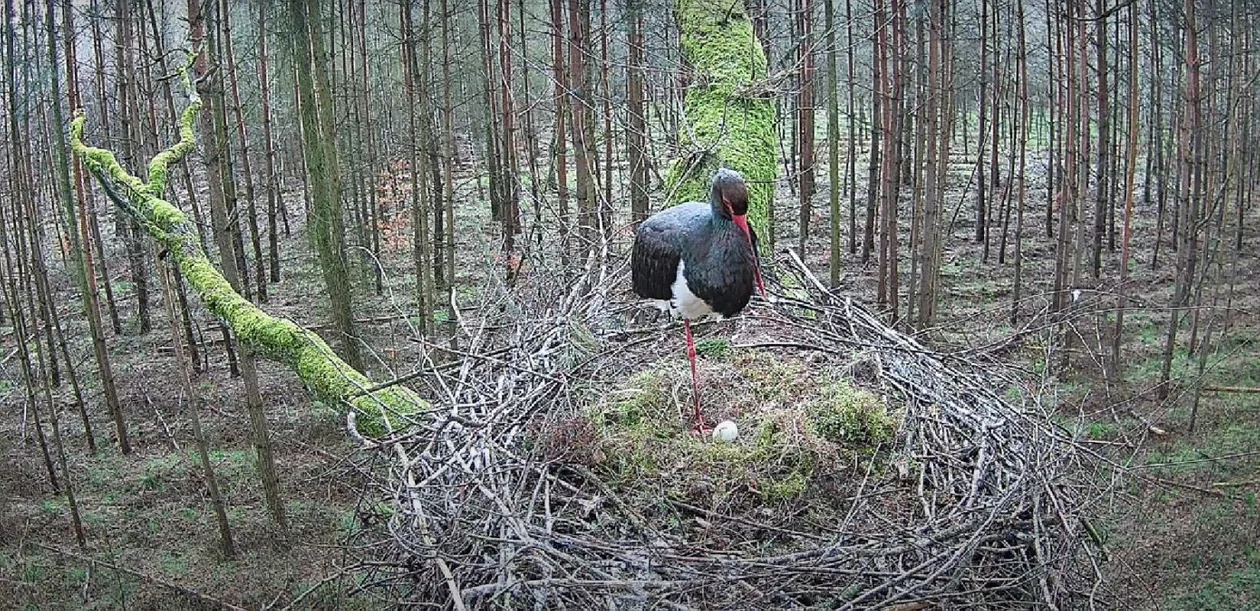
630,169,766,432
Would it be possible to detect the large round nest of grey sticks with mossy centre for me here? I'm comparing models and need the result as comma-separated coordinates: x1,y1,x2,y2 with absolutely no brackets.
369,250,1095,608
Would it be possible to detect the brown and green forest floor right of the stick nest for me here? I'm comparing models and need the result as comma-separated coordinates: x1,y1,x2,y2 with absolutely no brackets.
796,162,1260,611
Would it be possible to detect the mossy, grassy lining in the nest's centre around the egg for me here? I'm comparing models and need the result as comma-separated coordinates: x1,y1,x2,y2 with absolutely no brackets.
583,351,898,510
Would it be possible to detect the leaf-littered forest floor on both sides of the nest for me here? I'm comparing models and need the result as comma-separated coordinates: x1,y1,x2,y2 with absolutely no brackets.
0,145,1260,610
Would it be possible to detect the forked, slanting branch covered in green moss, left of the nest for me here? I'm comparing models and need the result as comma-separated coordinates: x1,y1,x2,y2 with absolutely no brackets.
71,77,428,437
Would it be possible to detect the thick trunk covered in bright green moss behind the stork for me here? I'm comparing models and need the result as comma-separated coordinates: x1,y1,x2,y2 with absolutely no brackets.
670,0,779,241
